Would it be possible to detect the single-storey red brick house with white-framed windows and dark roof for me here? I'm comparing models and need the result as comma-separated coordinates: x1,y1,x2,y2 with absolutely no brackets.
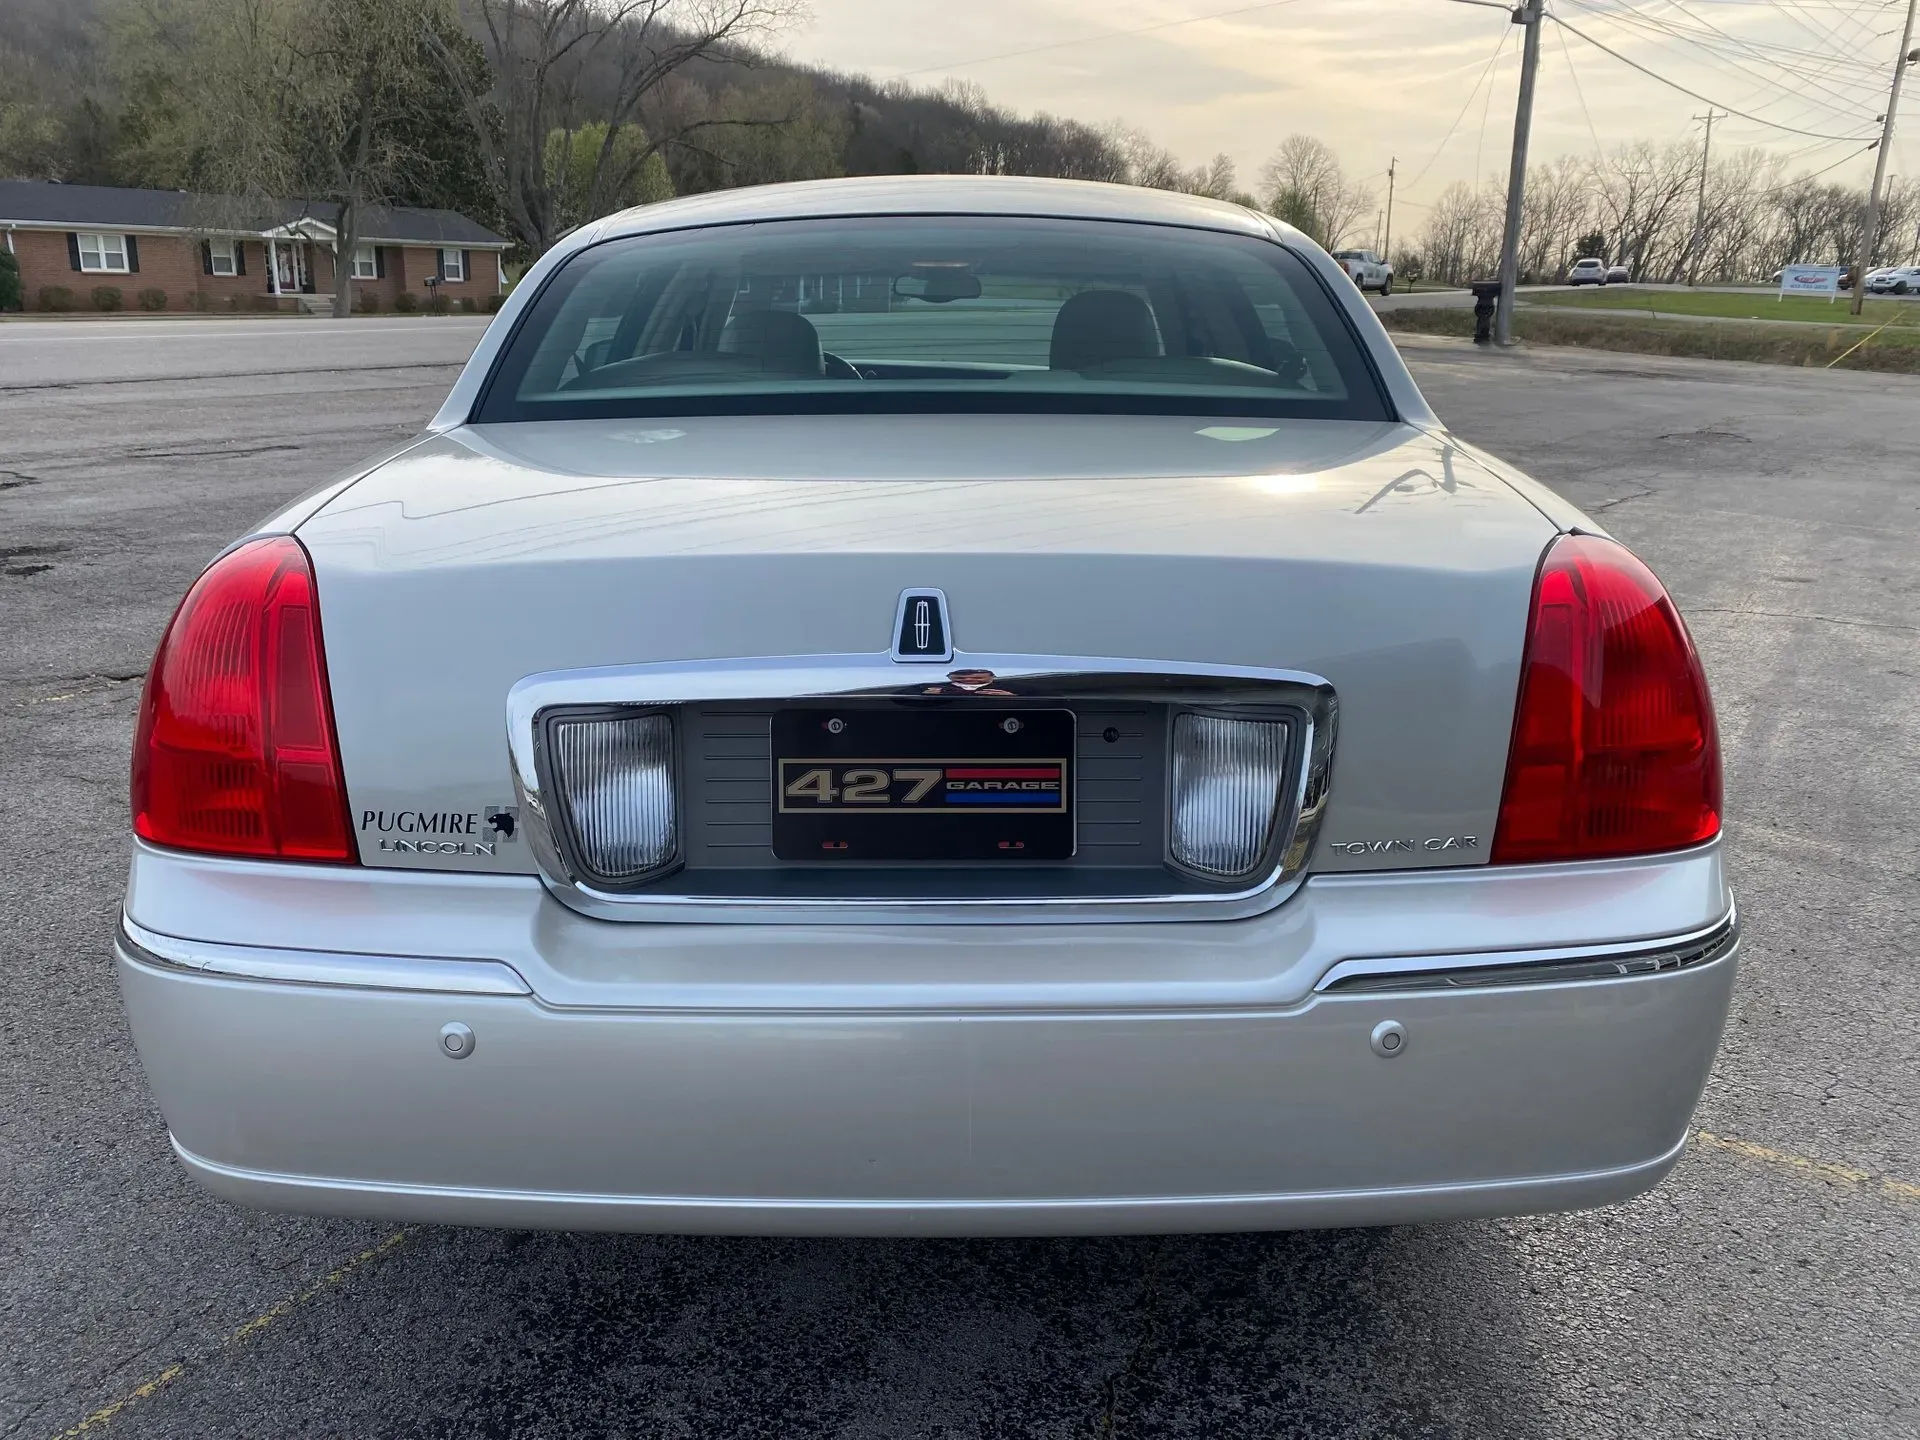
0,180,509,311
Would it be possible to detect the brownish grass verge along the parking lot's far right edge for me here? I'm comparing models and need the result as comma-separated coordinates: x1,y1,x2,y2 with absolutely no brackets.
1380,305,1920,374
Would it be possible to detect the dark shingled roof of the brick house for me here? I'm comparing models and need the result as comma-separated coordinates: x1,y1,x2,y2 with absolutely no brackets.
0,180,511,250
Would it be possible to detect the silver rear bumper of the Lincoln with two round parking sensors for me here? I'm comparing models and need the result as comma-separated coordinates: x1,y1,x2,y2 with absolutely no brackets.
115,851,1736,1235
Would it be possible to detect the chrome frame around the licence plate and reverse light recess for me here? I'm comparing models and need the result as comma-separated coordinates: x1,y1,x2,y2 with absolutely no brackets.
507,651,1338,925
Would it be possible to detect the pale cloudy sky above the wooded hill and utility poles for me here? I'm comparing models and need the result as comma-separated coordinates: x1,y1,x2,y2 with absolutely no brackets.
781,0,1920,228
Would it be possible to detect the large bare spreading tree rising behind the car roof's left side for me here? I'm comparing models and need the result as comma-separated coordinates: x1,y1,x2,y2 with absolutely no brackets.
434,0,801,255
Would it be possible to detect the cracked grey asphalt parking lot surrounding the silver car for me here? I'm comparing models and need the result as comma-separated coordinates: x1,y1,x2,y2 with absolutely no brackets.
0,319,1920,1440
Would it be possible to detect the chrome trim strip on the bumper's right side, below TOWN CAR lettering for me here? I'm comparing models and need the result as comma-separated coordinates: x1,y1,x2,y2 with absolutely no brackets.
1313,908,1740,995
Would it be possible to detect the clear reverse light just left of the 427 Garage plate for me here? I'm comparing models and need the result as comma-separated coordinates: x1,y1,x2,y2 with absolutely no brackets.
549,714,680,881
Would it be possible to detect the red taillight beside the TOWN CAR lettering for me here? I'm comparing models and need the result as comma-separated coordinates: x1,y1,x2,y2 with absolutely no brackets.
1494,536,1720,864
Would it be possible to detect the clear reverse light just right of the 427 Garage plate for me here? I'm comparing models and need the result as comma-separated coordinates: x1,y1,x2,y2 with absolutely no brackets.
1169,714,1286,879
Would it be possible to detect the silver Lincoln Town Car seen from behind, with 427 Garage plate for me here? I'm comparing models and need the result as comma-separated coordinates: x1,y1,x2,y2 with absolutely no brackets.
117,177,1736,1235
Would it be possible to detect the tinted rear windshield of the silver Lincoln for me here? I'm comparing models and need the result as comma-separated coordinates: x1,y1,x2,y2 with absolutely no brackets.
474,217,1390,420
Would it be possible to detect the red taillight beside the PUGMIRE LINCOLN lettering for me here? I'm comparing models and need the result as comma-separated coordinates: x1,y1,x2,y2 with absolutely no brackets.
132,536,353,860
